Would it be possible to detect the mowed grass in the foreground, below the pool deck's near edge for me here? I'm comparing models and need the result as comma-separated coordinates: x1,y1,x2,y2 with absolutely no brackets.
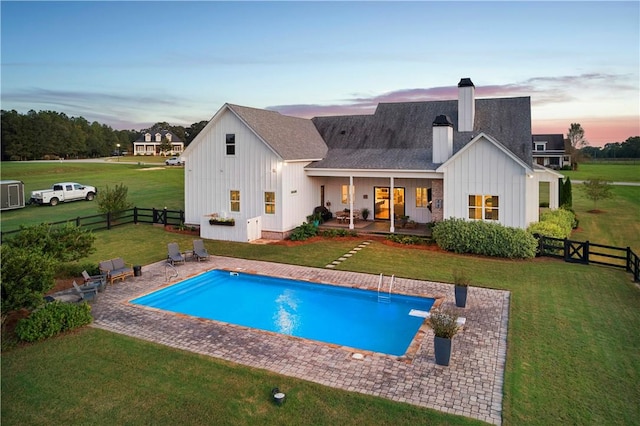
2,328,481,425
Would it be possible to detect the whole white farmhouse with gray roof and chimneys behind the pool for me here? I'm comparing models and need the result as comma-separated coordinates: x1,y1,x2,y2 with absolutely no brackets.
183,78,561,241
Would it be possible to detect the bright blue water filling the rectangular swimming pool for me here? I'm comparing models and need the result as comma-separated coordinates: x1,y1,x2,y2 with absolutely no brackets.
131,270,434,356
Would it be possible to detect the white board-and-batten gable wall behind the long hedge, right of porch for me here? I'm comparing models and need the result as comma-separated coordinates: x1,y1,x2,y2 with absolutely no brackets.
442,138,537,228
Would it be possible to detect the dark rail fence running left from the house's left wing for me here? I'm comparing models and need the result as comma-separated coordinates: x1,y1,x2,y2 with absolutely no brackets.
0,207,184,242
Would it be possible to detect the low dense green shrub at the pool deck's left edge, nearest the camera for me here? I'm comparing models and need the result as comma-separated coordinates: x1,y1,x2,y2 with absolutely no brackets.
16,302,93,342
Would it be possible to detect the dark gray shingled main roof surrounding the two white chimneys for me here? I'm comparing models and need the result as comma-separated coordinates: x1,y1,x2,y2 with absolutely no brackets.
307,97,532,170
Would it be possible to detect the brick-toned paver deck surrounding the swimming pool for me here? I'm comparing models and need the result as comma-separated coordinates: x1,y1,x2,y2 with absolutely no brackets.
92,256,509,424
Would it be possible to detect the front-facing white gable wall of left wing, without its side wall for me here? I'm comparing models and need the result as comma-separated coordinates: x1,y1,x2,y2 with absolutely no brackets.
185,110,281,241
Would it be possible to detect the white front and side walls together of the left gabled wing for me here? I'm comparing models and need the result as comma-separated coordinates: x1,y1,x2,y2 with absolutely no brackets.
185,106,314,242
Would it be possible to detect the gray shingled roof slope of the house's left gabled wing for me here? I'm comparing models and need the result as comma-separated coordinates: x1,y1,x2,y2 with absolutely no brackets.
227,104,327,160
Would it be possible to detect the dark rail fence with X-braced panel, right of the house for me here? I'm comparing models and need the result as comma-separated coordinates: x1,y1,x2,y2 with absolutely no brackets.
536,235,640,282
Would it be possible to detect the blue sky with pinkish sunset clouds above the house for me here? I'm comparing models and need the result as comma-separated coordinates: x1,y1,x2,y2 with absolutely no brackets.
0,0,640,146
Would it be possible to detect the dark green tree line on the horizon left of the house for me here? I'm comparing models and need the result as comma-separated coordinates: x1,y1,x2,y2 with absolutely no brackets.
0,110,207,161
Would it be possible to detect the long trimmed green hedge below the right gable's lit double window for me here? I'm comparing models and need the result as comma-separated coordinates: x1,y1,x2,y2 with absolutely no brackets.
433,219,538,259
